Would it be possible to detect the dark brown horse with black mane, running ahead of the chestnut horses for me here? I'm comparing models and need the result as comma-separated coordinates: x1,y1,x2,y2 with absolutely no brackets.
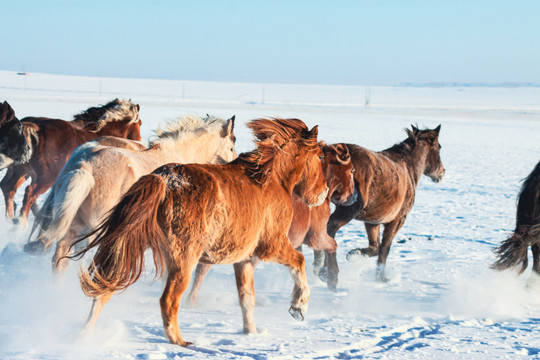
315,125,445,286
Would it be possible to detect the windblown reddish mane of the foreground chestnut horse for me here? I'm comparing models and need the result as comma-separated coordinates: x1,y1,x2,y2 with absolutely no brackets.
234,118,318,185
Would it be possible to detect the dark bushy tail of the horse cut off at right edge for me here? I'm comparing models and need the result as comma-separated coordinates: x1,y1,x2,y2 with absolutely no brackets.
491,225,540,274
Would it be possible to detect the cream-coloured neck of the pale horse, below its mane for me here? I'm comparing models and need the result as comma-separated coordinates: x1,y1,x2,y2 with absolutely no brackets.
153,134,217,164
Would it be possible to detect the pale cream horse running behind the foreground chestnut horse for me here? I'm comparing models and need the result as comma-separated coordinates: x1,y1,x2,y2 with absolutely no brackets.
24,116,237,273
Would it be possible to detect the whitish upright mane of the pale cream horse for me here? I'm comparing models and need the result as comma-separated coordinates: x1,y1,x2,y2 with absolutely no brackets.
150,115,227,146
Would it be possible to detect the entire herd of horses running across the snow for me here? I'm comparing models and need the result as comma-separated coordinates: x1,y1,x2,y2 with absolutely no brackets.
0,99,540,346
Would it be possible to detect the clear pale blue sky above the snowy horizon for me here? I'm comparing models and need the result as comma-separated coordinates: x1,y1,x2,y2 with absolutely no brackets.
0,0,540,85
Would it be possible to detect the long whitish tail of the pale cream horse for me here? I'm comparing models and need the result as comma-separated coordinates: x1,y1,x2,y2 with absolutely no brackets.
25,169,95,252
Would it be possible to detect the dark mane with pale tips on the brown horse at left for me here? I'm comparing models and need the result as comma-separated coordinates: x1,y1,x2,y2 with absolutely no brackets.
73,99,139,129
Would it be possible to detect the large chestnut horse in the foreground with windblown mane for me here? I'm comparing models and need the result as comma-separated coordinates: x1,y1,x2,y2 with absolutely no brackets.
69,119,328,346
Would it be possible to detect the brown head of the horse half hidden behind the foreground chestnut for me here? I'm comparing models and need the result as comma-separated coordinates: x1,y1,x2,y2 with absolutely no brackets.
319,142,358,206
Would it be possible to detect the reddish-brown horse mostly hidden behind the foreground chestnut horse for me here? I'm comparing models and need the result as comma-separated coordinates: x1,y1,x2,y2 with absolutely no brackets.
188,142,357,307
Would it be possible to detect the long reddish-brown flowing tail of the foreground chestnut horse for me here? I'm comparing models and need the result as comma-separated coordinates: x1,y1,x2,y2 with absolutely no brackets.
69,174,167,298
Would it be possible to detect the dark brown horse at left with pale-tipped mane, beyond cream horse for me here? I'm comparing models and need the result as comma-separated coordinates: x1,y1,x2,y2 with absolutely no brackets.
0,99,141,223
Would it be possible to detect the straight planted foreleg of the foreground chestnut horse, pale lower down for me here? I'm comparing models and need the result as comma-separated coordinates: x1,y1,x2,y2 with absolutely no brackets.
234,258,257,334
